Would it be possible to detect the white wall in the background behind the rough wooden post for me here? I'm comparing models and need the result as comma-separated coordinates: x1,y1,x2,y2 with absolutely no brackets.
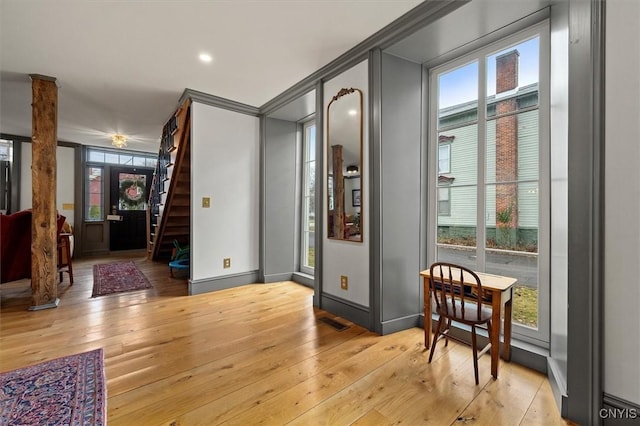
20,142,76,225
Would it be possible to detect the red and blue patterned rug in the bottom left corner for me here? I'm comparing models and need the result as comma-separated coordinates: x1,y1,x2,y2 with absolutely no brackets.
0,349,107,425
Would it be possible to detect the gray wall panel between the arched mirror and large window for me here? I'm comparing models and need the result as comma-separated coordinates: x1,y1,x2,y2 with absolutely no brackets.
372,53,423,334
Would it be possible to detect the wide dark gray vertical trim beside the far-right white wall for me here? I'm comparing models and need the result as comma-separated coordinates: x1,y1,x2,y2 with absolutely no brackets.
562,0,604,425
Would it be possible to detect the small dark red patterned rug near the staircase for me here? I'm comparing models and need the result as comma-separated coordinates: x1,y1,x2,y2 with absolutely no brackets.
91,261,153,297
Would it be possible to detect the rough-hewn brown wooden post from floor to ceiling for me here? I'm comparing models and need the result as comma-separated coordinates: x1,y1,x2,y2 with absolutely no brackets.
29,74,59,310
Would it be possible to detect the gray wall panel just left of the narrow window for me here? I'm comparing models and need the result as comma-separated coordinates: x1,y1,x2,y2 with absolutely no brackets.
263,118,298,282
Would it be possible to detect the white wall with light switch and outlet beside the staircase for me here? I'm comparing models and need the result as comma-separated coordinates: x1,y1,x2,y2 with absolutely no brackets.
191,102,260,281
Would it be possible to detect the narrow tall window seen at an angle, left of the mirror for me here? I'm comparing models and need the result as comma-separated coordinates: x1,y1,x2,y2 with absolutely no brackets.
300,121,316,274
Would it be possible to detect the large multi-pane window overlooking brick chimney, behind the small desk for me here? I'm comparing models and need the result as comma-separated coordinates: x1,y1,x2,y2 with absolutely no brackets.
429,24,550,345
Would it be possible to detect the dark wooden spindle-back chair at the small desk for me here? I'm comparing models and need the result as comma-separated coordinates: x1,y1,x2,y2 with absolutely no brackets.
429,262,492,385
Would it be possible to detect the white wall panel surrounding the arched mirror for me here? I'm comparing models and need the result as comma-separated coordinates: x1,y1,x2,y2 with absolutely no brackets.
322,61,370,307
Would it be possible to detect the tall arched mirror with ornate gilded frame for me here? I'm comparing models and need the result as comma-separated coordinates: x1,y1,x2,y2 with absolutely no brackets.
327,88,364,242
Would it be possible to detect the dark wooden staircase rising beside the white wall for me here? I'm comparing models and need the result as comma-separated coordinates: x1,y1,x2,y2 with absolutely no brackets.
147,101,191,260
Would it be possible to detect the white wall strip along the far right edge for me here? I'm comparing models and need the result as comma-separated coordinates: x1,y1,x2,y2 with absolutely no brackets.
604,0,640,404
